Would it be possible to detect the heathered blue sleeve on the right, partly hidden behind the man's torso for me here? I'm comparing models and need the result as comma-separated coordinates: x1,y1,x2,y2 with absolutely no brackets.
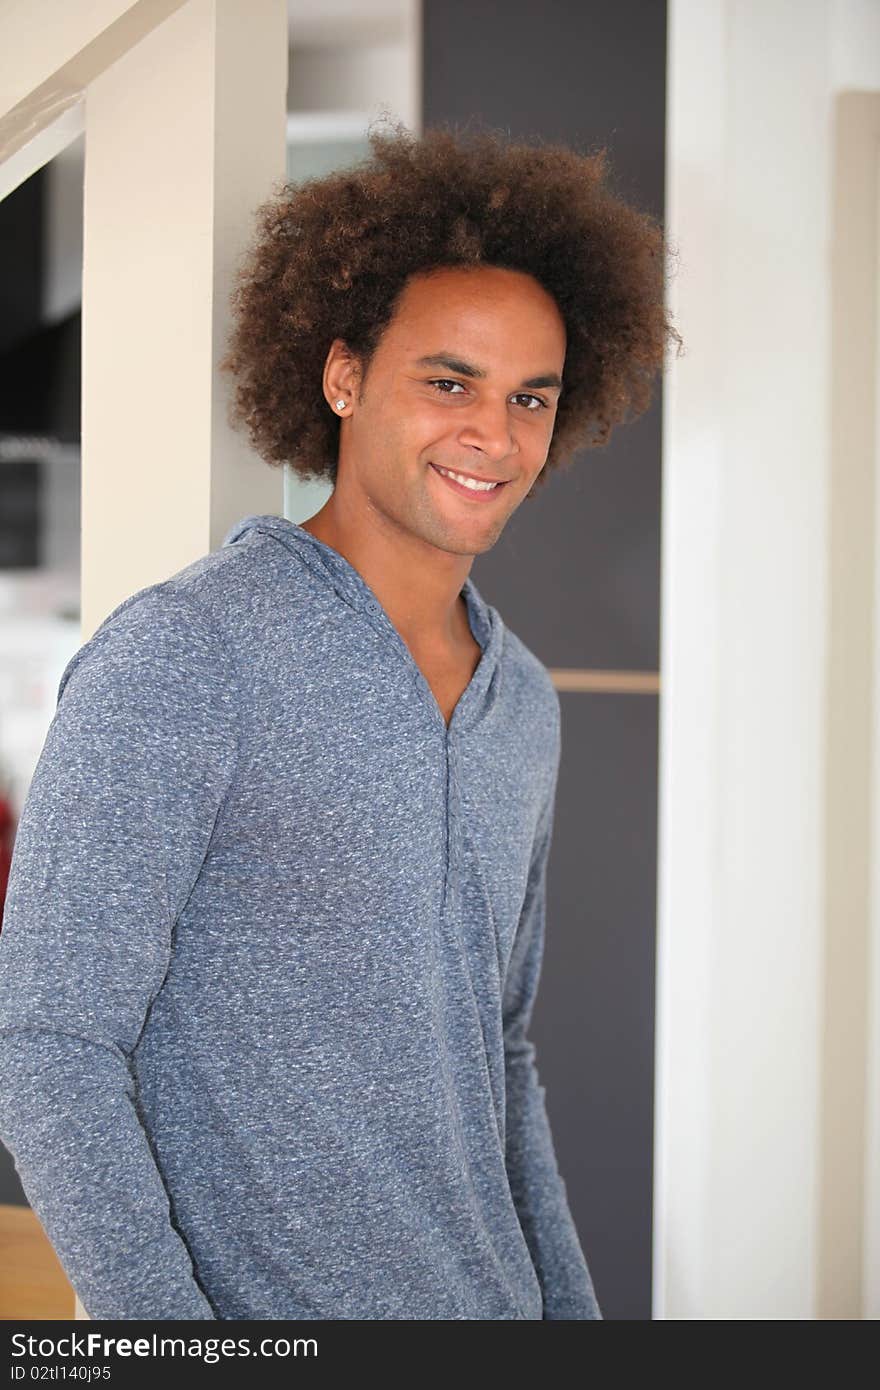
503,700,602,1319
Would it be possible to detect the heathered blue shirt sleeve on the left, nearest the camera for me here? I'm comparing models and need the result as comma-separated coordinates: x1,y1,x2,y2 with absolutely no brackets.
0,585,238,1319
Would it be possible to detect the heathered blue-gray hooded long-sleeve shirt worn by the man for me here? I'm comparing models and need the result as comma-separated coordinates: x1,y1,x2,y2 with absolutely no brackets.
0,516,602,1319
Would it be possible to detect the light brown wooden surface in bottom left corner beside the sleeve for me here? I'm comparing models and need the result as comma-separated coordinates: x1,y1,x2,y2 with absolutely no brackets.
0,1202,75,1322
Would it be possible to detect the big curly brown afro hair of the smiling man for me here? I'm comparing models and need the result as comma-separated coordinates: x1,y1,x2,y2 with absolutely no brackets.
220,120,681,492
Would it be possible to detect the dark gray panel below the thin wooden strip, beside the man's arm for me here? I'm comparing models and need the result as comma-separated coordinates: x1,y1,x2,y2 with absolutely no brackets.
532,692,659,1319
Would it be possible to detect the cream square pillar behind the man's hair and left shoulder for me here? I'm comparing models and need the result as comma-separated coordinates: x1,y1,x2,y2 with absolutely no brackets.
82,0,288,639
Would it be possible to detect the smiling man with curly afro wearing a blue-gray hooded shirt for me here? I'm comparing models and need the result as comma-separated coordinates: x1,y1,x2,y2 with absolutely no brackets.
0,129,670,1319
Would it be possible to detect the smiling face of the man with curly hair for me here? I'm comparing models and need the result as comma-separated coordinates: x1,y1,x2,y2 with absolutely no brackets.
328,267,566,555
